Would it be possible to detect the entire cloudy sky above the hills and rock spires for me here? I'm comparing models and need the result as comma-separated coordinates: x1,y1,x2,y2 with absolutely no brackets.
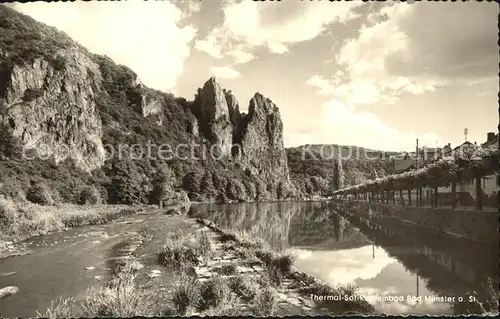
14,0,499,151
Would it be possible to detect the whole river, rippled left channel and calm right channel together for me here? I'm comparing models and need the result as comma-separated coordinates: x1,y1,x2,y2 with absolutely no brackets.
0,202,498,317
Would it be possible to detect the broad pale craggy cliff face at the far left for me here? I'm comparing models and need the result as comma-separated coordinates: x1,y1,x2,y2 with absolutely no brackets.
0,48,105,171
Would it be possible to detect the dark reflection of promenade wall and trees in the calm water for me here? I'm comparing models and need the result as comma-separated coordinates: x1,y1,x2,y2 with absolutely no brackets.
337,205,498,314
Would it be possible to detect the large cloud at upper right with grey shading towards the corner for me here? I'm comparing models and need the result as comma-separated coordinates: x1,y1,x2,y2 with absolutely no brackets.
307,3,498,104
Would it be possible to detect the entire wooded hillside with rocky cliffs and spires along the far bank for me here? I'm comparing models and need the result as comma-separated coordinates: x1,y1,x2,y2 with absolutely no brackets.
0,5,394,208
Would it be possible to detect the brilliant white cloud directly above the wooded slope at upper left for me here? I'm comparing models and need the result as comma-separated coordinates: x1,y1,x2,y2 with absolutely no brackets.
15,1,197,91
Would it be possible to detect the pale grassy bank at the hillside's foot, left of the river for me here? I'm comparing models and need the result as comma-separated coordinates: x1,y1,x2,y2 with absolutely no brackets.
0,195,135,241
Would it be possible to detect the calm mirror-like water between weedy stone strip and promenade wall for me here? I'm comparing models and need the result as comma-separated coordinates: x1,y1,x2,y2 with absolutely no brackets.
190,202,498,314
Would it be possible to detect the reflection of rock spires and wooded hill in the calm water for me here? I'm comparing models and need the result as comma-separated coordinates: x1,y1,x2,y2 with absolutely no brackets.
190,202,370,250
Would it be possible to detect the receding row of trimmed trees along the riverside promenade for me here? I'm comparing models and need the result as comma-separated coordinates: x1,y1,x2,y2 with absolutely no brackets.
333,146,499,211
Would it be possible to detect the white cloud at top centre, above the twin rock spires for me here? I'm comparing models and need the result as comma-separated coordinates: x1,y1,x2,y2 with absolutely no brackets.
197,0,363,63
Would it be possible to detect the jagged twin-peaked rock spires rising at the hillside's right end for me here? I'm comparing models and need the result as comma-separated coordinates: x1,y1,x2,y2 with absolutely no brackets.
194,77,290,189
